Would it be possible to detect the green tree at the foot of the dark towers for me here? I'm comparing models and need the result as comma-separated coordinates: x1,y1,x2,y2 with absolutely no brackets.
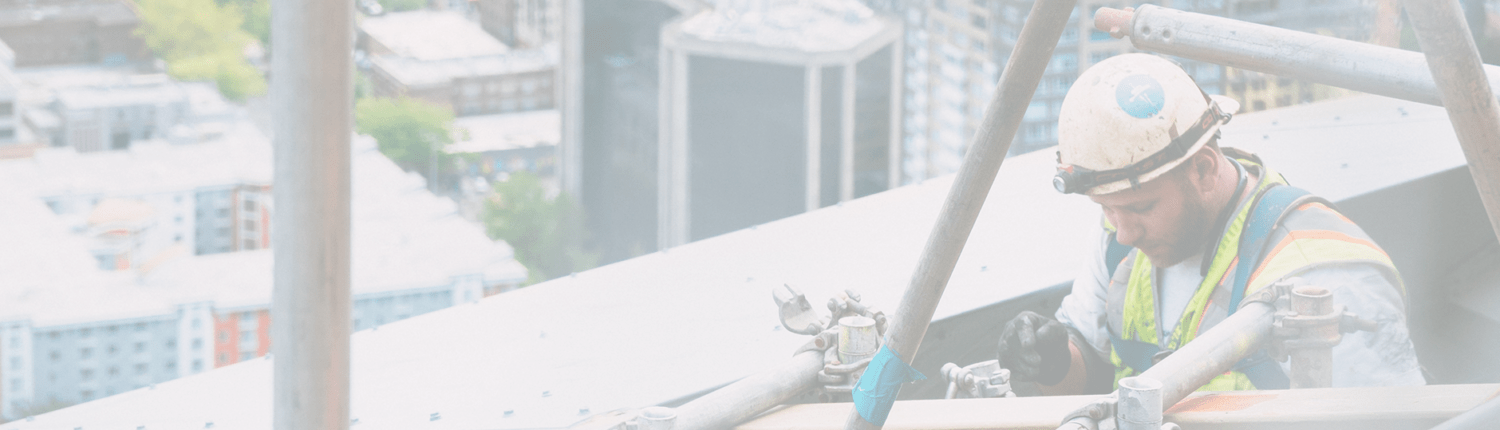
483,172,599,285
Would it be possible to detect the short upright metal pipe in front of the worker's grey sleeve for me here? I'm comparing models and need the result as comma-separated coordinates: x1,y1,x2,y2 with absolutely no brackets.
1283,286,1343,388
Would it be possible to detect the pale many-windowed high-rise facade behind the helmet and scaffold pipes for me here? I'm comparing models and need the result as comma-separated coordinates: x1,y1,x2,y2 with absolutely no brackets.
888,0,1374,183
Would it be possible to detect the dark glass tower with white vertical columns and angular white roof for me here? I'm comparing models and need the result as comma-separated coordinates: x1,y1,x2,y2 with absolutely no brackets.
657,0,902,247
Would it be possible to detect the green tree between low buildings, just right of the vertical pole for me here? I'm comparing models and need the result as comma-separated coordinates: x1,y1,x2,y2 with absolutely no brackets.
354,97,458,186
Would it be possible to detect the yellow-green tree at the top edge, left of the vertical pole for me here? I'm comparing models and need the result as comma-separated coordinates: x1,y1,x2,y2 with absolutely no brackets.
137,0,270,100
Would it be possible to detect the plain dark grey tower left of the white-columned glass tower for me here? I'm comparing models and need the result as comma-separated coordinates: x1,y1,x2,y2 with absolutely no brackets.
558,0,684,262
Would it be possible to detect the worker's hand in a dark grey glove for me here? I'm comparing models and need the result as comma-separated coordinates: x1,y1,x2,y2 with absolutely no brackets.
999,310,1073,385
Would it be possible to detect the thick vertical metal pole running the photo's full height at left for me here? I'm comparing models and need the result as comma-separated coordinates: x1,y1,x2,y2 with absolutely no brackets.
272,0,354,430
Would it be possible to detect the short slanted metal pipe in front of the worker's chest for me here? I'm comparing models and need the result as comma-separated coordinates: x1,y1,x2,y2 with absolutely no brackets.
1140,301,1277,408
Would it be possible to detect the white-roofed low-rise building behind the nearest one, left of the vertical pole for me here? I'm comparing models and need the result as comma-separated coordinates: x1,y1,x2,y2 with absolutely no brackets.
0,121,272,259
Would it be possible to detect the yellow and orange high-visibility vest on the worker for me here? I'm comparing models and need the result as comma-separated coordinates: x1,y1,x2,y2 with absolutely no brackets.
1104,153,1406,391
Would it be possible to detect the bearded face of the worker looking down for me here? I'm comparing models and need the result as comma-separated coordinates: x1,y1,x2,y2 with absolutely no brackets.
1089,160,1214,267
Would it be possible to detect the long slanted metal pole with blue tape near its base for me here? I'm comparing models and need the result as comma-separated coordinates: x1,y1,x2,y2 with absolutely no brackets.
845,0,1079,430
